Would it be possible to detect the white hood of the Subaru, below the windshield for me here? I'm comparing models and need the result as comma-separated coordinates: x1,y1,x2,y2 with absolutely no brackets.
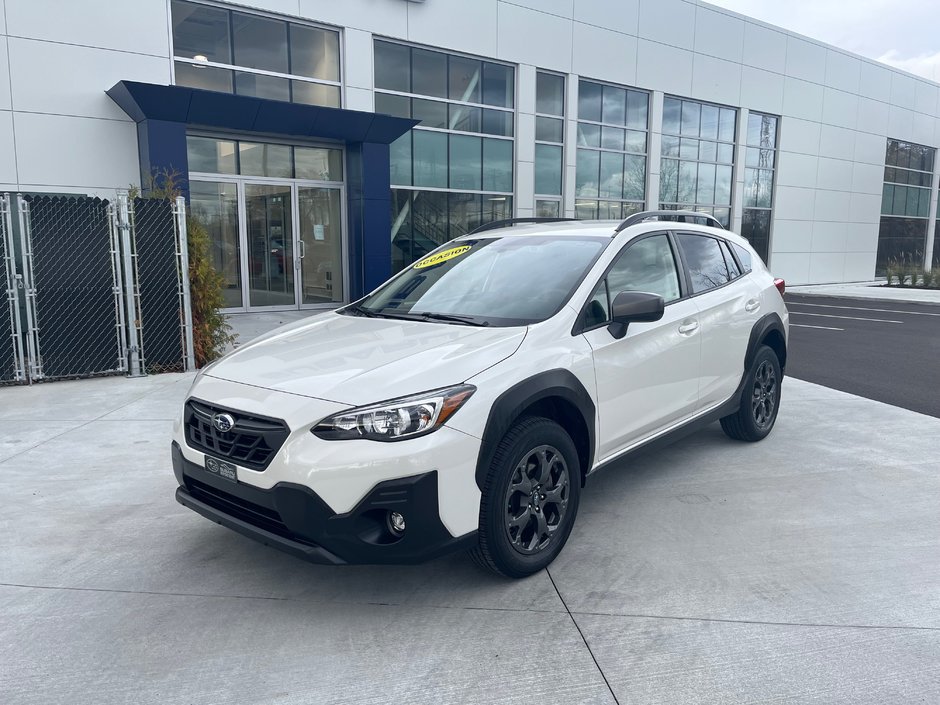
206,312,526,406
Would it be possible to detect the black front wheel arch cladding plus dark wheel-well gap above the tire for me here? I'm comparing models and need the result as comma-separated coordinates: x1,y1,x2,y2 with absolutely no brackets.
476,369,596,491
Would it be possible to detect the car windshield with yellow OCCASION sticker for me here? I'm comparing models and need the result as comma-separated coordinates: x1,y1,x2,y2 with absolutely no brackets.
344,236,610,326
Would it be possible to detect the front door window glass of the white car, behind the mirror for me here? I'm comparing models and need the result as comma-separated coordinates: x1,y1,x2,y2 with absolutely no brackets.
584,234,681,328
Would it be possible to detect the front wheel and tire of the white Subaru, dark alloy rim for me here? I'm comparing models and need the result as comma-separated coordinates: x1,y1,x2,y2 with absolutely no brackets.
470,417,581,578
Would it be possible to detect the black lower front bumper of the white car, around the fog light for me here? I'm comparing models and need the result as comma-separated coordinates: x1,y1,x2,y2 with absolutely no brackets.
172,442,476,565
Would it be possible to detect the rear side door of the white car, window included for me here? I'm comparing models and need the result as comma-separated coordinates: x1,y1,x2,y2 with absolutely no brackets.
676,232,760,409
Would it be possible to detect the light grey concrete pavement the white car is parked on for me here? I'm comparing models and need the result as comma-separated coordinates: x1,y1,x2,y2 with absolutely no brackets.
0,375,940,705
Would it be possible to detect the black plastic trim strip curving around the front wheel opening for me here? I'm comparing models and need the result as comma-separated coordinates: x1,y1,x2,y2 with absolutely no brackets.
475,369,597,490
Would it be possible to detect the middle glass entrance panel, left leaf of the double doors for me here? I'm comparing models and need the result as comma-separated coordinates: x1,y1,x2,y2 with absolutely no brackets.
244,183,297,309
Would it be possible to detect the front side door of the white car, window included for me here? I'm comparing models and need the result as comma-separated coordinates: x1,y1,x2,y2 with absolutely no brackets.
582,232,701,460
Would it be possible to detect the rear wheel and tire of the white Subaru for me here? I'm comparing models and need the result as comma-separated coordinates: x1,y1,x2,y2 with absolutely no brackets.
721,345,783,442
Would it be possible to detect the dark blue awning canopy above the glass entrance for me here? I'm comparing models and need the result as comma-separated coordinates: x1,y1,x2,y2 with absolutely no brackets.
107,81,418,144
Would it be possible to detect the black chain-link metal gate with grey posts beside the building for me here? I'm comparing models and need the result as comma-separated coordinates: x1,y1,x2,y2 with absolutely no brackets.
0,192,195,383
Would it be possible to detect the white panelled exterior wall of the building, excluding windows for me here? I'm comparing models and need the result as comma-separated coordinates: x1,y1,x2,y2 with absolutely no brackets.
0,0,940,284
